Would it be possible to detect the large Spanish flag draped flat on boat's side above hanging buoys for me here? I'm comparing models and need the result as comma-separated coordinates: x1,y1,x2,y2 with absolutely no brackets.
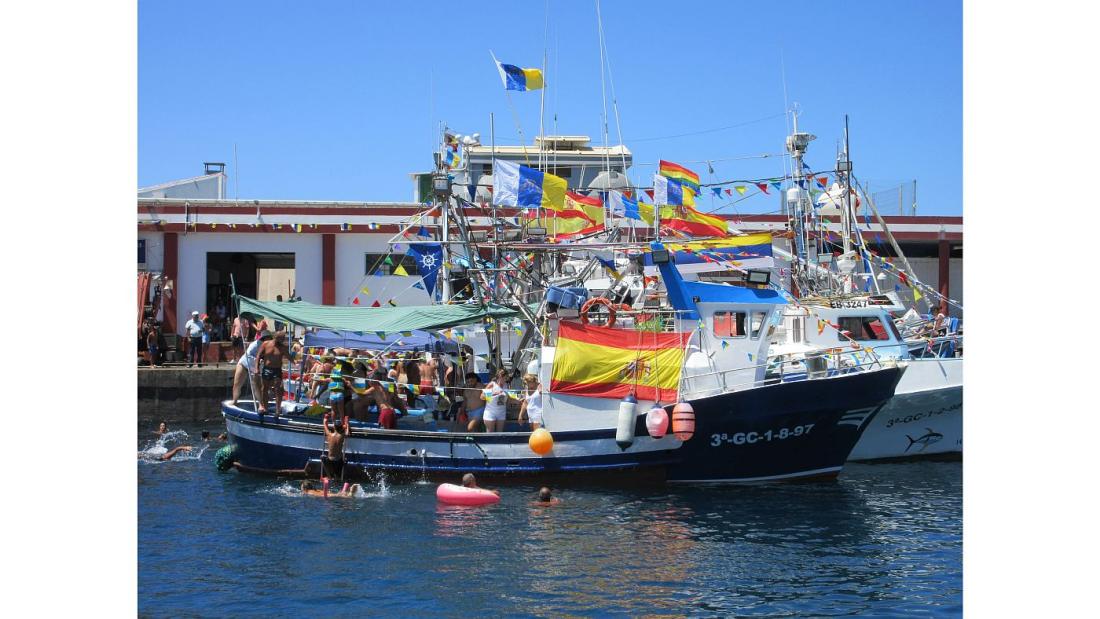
550,321,691,402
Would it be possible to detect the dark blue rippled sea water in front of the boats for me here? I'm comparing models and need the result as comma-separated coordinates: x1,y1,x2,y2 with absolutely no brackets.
138,427,963,617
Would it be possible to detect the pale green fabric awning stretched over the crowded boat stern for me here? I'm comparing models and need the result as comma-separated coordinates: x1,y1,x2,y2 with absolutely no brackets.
237,296,528,333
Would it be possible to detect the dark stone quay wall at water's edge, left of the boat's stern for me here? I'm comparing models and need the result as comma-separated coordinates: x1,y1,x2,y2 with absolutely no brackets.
138,364,233,427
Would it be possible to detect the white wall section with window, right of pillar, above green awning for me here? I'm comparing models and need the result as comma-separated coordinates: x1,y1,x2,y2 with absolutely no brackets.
336,234,431,306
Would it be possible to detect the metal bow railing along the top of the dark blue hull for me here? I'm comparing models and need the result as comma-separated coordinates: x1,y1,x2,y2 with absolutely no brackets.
681,349,898,398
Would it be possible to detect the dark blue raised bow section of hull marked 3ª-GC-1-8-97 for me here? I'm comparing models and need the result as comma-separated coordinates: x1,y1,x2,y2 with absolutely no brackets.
668,368,901,482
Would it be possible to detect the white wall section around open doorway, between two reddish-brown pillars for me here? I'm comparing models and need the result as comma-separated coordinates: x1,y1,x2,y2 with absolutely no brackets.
176,232,321,331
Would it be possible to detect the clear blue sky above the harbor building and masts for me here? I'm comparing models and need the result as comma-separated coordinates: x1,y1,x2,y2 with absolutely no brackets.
138,0,963,214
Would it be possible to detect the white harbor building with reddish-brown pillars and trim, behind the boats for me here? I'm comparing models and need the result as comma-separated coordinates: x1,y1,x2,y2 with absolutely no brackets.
138,157,964,333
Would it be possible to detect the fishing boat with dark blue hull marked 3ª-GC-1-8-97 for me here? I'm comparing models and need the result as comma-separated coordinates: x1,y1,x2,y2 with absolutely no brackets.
222,244,903,484
